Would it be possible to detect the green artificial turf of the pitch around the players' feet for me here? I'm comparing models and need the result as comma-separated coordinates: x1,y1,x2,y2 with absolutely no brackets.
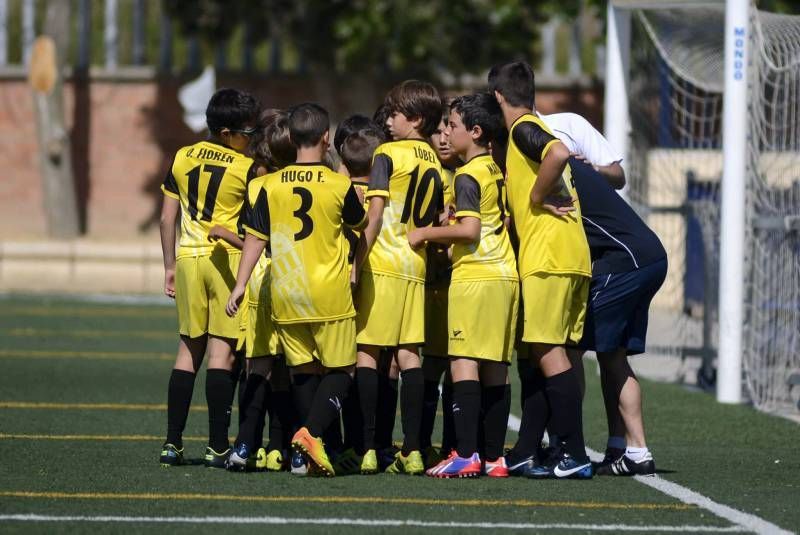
0,297,800,533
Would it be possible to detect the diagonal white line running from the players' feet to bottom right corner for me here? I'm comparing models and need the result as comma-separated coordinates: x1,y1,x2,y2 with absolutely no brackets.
508,414,792,535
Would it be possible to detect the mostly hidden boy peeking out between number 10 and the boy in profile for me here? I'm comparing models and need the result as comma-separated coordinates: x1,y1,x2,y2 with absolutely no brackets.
420,115,461,468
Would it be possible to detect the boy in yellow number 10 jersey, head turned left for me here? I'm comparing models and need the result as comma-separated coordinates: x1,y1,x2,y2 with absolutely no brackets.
352,80,443,474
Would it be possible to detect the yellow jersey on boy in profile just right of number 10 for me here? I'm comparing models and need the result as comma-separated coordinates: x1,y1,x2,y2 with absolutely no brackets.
452,154,518,281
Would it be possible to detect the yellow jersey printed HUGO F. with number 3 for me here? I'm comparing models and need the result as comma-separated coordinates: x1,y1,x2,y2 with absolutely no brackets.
245,163,366,324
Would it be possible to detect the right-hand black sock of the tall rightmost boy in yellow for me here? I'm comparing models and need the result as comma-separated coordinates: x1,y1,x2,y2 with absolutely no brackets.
546,368,586,459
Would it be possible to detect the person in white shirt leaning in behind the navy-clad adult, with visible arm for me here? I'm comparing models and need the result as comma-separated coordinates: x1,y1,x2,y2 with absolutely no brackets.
536,112,625,189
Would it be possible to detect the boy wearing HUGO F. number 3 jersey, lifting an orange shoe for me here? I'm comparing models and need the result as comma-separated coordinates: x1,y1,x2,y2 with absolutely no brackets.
227,104,366,476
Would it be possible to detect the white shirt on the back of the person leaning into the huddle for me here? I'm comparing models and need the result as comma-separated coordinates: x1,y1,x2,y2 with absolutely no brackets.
537,113,622,169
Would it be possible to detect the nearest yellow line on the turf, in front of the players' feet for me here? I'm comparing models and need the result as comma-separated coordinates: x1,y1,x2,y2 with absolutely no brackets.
0,491,697,510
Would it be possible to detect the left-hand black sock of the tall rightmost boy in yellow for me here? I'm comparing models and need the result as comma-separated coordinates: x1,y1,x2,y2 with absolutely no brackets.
509,366,550,464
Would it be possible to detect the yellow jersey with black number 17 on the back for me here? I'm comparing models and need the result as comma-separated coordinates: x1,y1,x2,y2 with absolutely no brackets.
161,141,256,255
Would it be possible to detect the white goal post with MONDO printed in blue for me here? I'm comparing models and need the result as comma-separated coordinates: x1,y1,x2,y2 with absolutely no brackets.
717,0,750,403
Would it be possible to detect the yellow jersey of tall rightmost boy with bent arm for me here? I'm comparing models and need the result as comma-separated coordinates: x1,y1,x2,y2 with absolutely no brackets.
506,114,592,278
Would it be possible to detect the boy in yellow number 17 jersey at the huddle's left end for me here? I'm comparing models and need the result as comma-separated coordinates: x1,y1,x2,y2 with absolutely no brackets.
160,89,259,468
